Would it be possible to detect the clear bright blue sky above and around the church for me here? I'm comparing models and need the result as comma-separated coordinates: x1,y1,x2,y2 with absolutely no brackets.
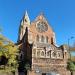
0,0,75,45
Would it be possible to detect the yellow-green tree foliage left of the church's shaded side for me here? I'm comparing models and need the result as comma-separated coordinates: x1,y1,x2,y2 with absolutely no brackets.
0,35,19,71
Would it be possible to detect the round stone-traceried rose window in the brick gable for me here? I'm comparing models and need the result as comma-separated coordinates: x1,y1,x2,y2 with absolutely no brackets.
36,21,48,32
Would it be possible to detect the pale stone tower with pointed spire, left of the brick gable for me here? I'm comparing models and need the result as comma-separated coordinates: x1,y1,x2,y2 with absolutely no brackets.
18,11,30,41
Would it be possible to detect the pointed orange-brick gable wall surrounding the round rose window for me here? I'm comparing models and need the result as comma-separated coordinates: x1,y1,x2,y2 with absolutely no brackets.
29,15,55,44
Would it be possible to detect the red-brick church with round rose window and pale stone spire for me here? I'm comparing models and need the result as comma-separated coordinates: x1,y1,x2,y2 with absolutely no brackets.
18,12,68,75
